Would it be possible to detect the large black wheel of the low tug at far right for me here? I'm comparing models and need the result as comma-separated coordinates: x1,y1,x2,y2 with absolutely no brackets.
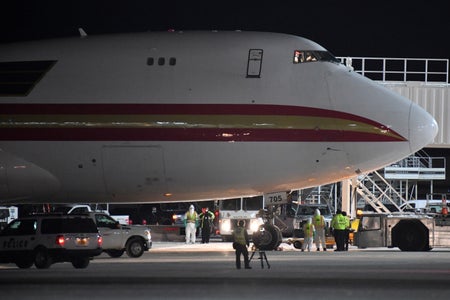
392,220,430,251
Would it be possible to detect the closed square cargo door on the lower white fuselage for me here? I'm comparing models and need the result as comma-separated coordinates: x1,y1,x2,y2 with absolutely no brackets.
102,146,166,199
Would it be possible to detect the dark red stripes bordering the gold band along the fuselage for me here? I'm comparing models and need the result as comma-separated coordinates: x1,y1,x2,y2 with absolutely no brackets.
0,103,406,142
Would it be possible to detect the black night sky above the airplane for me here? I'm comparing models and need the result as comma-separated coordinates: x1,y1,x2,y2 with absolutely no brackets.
0,0,450,58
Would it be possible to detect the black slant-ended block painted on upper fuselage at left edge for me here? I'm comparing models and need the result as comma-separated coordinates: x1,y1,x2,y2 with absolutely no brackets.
0,60,56,97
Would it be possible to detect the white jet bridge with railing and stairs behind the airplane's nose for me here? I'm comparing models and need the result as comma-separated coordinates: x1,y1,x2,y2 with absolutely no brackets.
338,57,450,216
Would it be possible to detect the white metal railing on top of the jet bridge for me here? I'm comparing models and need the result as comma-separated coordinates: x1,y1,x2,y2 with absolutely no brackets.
338,57,449,84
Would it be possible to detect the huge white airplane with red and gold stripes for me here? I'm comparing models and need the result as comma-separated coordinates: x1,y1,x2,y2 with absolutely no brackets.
0,31,438,204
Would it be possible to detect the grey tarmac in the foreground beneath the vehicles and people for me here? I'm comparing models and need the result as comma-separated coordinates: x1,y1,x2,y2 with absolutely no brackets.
0,241,450,300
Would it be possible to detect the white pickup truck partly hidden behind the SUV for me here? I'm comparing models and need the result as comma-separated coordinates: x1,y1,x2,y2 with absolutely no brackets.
87,212,152,257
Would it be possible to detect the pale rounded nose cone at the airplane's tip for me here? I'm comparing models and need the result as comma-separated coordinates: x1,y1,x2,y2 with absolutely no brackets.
409,103,438,152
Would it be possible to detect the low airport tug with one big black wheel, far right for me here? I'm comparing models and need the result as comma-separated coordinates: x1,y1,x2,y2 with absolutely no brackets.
354,213,450,251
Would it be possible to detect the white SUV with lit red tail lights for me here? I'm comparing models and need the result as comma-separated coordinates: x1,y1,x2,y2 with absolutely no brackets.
0,215,102,269
